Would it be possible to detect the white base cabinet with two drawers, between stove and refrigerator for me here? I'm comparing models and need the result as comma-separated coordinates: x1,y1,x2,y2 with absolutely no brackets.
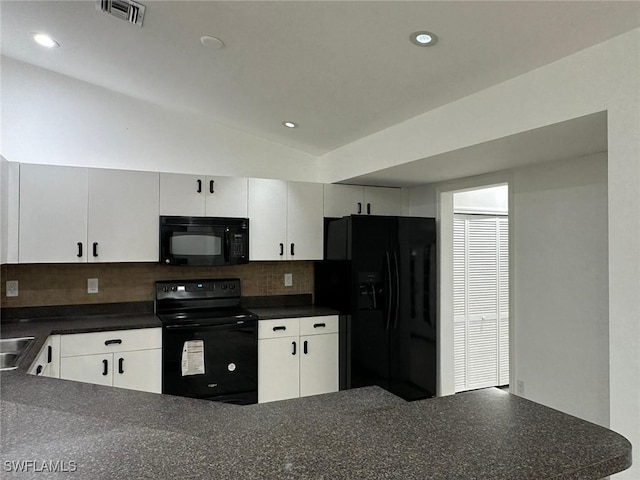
258,315,338,403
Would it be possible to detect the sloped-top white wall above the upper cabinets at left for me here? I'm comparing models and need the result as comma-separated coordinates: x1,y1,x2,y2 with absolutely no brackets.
0,57,317,182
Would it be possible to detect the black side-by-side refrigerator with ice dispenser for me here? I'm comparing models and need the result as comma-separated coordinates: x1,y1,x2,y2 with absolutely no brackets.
314,215,437,401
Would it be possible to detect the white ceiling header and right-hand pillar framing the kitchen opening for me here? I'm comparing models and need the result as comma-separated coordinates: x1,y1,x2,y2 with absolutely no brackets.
332,29,640,479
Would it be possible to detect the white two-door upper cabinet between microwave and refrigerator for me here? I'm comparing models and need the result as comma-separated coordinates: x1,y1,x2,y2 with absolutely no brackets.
249,178,323,260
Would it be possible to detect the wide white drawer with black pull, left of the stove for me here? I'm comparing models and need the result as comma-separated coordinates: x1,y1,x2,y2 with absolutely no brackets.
60,328,162,357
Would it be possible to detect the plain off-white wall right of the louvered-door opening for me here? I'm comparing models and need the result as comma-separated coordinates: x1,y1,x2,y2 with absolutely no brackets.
511,154,610,426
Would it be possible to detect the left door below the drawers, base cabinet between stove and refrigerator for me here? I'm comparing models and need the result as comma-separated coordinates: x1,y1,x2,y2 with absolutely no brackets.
258,337,300,403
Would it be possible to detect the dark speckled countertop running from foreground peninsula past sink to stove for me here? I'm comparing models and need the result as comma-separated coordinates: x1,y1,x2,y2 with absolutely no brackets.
0,312,631,480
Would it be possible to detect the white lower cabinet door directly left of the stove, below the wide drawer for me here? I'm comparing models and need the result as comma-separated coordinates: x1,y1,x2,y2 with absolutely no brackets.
113,348,162,393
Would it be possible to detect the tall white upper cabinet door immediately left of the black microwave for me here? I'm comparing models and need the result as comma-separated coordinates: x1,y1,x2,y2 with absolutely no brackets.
88,169,159,262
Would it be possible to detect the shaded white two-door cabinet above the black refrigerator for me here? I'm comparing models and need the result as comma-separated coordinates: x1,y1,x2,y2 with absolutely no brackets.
324,184,402,217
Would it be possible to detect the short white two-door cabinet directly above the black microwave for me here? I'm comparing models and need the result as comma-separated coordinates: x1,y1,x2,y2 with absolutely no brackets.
160,173,248,218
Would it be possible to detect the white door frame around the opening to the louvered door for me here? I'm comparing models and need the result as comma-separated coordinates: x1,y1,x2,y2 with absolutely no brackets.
436,172,517,397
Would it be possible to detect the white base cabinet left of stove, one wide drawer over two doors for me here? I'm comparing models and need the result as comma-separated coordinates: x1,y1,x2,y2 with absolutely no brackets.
60,328,162,393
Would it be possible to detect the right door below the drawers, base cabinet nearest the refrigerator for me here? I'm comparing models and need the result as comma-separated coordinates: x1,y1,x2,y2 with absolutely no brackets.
300,333,339,397
